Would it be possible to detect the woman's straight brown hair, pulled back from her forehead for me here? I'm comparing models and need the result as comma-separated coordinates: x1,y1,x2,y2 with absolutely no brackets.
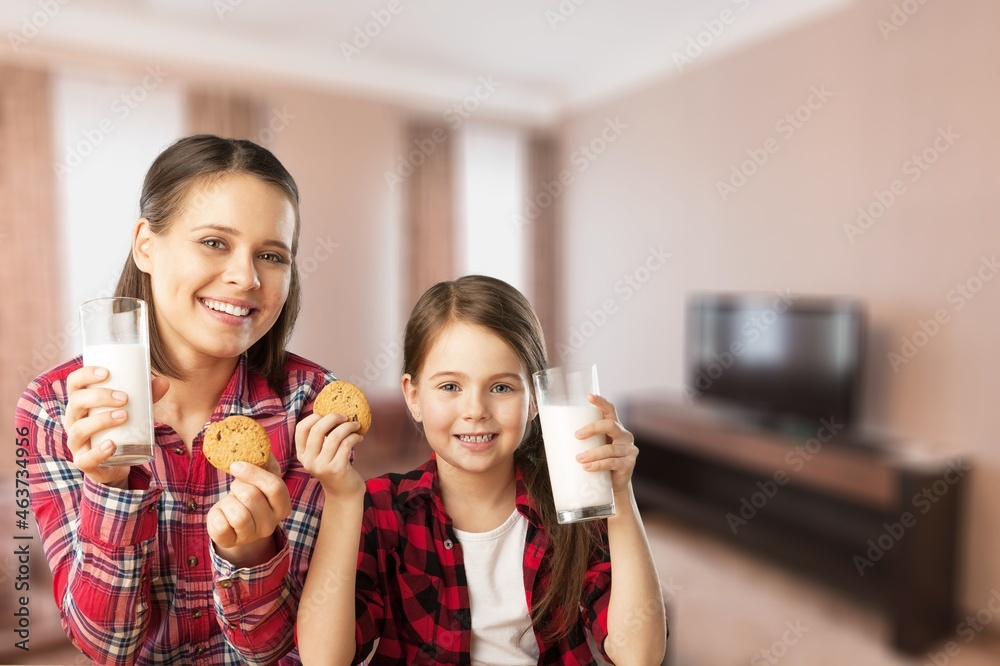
115,134,301,390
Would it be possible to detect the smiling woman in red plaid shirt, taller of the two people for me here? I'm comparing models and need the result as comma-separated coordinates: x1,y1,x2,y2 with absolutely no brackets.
16,135,333,665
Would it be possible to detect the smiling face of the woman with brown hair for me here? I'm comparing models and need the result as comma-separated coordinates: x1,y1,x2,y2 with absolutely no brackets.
132,174,298,379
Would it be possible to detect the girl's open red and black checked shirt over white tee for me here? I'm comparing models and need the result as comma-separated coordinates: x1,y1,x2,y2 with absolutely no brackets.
354,456,611,666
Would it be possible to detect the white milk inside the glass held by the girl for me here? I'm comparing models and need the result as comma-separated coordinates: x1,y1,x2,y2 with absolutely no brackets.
538,405,614,522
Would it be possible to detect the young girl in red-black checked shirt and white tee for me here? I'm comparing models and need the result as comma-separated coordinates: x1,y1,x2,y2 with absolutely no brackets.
295,276,666,665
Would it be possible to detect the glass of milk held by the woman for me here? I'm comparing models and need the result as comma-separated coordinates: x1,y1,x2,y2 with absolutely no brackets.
80,298,153,467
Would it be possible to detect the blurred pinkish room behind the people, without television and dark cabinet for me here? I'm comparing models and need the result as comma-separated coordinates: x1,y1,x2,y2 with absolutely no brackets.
0,0,1000,666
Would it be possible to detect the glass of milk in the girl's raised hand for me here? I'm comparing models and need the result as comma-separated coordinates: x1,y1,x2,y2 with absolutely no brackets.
532,364,615,523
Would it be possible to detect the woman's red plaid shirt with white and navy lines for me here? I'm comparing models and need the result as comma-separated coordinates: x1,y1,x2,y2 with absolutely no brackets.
15,354,333,665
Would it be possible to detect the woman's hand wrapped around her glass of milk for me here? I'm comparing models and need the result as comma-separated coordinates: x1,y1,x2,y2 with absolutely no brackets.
63,365,170,490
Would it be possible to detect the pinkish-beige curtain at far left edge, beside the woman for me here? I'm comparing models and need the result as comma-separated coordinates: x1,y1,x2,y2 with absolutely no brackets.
0,64,72,663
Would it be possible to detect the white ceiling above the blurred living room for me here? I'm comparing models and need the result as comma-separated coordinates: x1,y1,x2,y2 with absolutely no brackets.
0,0,852,123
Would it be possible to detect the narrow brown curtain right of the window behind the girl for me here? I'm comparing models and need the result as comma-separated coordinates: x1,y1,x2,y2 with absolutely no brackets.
522,135,564,358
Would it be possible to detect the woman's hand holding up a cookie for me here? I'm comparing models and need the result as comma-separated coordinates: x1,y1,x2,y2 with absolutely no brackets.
206,455,292,567
